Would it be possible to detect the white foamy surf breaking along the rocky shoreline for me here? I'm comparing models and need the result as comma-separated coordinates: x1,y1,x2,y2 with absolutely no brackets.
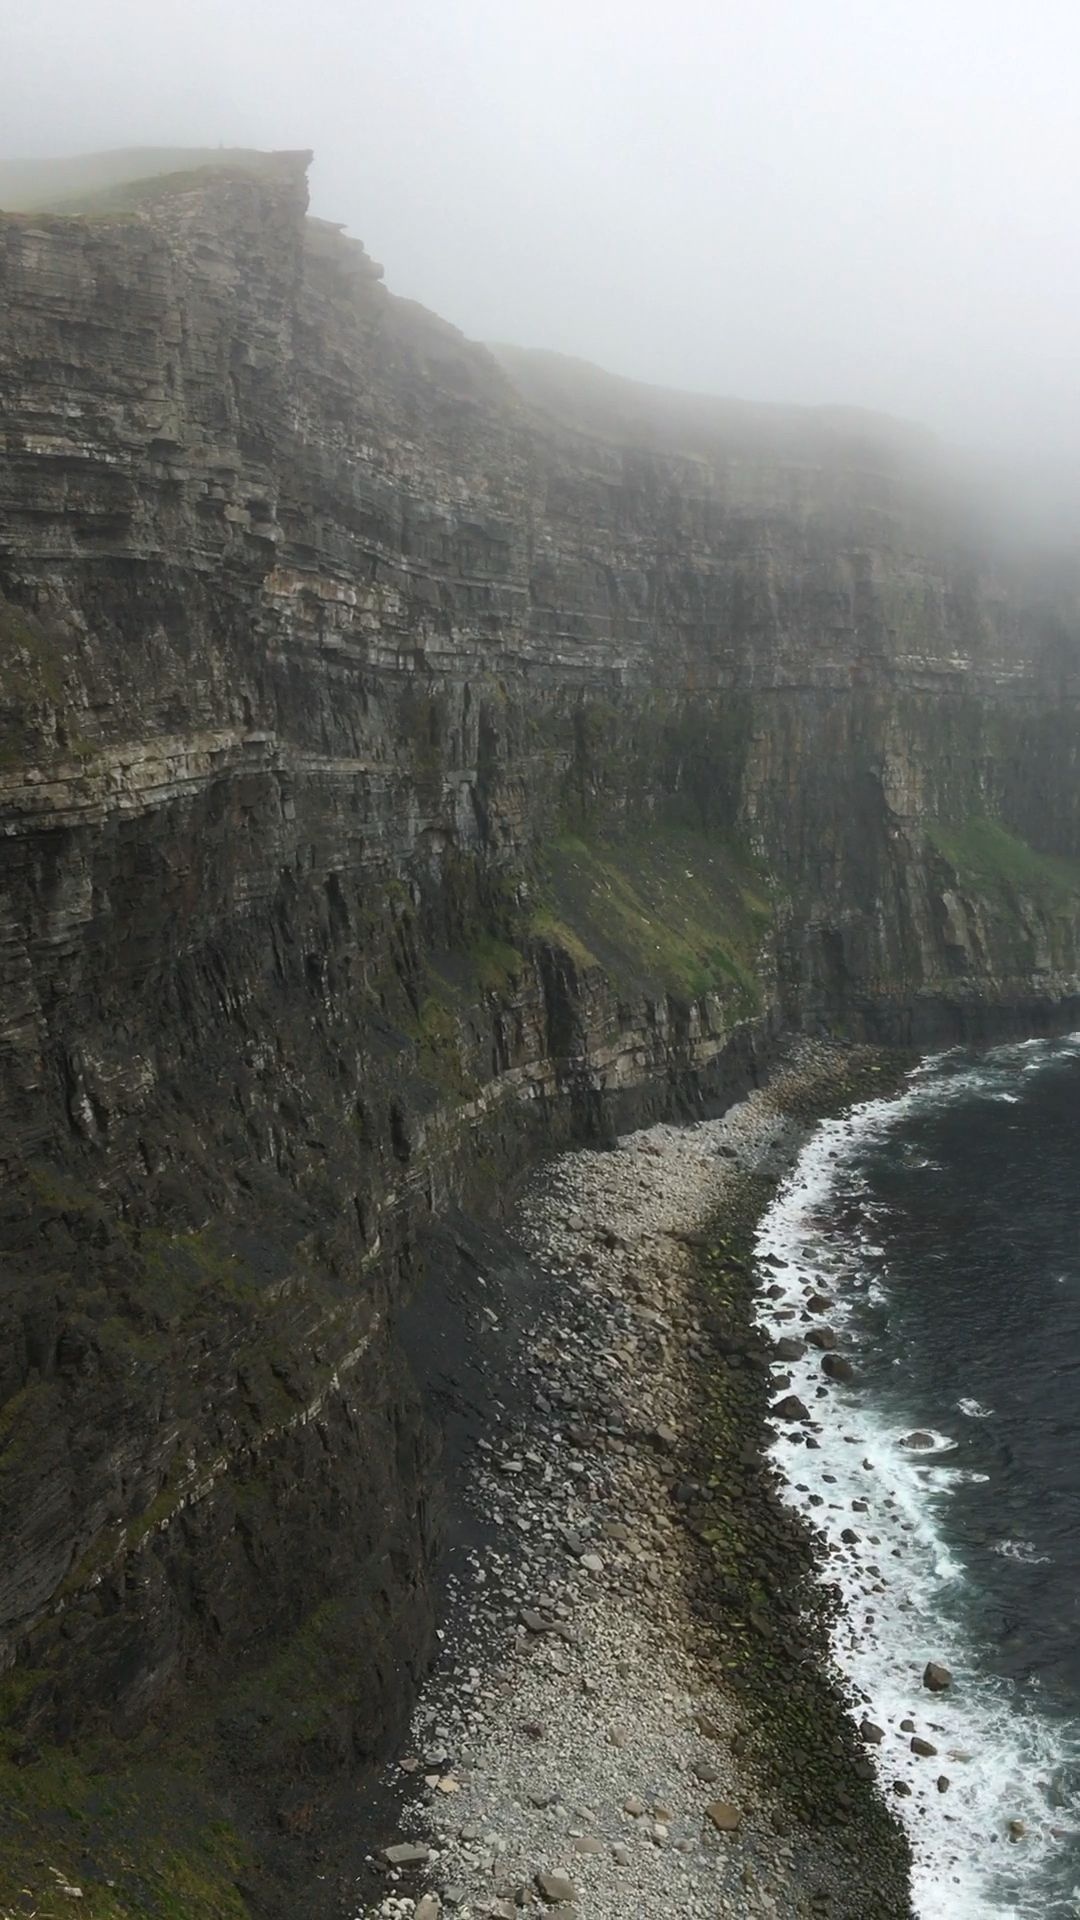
757,1037,1080,1920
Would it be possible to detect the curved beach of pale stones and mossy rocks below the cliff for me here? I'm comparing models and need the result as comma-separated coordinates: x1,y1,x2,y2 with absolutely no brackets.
363,1043,911,1920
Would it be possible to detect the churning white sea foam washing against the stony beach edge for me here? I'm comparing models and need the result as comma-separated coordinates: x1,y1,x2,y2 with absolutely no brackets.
757,1035,1080,1920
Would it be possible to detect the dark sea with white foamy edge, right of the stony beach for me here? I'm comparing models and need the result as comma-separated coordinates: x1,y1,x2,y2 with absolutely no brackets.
759,1035,1080,1920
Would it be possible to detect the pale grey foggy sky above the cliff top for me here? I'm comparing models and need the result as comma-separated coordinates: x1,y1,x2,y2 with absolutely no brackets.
0,0,1080,451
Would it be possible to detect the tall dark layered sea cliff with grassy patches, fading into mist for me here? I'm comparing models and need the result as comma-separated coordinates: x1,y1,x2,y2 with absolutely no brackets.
0,156,1080,1914
